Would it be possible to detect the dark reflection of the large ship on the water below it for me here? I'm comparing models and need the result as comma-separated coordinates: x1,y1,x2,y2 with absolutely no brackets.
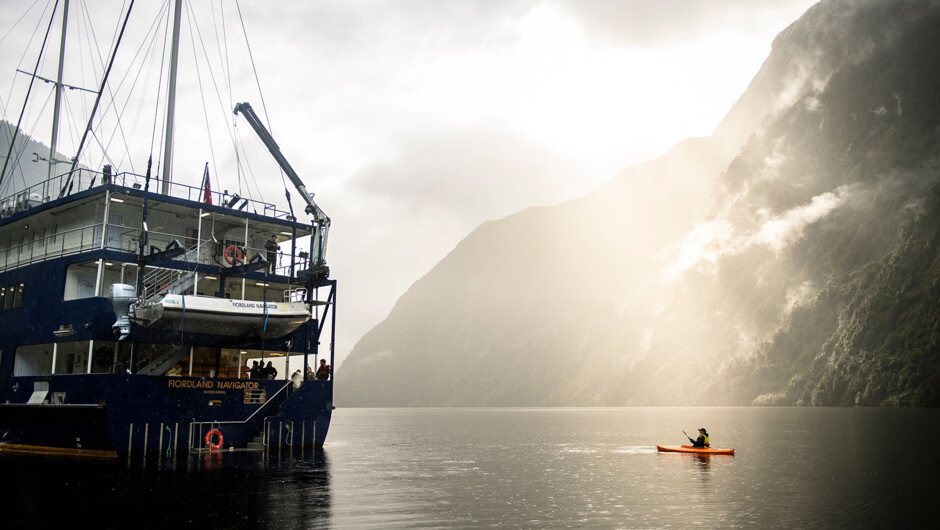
0,448,333,528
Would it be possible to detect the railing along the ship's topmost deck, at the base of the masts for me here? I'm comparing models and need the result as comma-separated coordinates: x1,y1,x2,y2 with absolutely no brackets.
0,168,290,219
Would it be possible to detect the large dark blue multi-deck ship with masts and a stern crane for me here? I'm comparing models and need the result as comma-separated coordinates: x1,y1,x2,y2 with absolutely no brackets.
0,2,336,458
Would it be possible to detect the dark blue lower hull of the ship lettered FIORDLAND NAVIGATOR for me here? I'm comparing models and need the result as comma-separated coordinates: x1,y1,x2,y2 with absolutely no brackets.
0,374,333,457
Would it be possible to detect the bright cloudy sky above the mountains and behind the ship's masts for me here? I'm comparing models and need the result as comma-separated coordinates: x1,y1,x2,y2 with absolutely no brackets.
0,0,815,359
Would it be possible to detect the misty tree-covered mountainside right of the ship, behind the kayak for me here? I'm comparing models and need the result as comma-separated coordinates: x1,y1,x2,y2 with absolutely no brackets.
336,0,940,406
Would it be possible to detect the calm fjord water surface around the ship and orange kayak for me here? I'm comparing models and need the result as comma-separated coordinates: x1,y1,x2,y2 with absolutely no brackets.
0,408,940,528
